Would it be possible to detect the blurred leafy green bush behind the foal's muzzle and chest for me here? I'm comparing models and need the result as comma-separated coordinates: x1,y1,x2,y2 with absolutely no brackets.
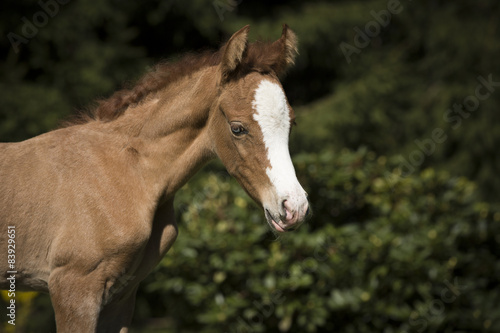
135,149,500,332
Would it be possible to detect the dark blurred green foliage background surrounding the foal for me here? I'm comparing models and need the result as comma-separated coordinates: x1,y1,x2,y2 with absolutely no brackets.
0,0,500,333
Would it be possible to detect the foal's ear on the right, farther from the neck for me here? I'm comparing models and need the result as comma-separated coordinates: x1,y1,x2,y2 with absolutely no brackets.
273,24,299,76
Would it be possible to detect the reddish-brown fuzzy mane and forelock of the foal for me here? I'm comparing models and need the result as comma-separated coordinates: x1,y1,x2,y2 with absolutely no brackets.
63,42,280,127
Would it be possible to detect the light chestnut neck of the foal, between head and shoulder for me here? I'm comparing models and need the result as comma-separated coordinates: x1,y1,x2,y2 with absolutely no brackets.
104,67,218,199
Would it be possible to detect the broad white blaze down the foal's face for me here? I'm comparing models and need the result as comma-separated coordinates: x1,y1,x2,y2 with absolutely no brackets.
252,80,307,209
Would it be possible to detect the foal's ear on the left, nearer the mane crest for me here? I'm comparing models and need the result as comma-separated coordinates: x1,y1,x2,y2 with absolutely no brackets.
220,25,250,82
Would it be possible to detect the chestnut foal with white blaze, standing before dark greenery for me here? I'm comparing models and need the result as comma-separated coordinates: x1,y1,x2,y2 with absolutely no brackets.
0,25,308,333
